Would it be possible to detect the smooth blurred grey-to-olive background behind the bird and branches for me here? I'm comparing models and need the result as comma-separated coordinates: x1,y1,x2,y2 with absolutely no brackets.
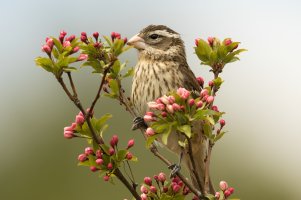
0,0,301,200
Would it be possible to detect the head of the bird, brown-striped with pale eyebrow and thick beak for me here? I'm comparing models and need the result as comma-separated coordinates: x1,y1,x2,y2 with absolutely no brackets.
128,25,185,59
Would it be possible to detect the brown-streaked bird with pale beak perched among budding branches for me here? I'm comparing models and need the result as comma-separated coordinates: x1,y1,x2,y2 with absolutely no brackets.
127,25,213,194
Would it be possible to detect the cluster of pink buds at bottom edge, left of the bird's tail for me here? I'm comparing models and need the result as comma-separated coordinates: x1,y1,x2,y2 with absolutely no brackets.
140,172,190,200
